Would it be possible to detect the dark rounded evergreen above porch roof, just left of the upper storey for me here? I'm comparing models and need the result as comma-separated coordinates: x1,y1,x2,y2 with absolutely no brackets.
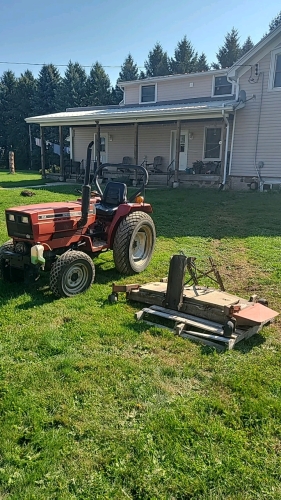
86,62,111,106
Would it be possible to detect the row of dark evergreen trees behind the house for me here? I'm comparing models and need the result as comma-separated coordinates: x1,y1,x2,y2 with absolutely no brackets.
0,11,281,169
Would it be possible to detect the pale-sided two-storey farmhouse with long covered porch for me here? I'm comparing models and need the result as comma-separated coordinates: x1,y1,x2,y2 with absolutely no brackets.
26,21,281,189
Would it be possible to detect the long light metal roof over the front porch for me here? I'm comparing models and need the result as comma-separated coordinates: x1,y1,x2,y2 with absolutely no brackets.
25,100,242,127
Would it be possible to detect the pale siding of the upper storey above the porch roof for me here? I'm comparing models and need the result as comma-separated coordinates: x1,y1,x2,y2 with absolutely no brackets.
122,73,228,105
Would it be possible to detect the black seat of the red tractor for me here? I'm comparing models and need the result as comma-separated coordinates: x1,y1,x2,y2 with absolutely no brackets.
96,181,127,215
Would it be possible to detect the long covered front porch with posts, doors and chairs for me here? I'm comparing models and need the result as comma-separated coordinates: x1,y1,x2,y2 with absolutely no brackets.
27,100,241,187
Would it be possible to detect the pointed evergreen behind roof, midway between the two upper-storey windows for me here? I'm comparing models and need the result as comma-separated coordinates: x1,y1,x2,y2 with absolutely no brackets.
170,36,197,74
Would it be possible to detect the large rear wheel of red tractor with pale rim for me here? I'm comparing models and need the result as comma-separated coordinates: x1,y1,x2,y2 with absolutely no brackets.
113,212,156,275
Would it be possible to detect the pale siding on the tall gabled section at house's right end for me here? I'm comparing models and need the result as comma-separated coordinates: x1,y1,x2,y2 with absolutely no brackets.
231,46,281,177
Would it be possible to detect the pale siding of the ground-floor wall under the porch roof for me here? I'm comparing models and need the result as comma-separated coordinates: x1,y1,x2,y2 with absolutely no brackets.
73,119,228,171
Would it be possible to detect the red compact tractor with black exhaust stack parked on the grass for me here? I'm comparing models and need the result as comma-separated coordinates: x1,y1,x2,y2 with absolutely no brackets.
0,142,155,297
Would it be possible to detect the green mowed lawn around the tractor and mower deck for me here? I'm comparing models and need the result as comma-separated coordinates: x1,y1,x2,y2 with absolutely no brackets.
0,178,281,500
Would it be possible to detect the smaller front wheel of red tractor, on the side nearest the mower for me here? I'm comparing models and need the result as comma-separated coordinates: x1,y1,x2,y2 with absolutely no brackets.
50,250,95,297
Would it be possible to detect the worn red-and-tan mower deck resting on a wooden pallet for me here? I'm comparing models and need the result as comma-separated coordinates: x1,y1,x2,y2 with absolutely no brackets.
108,255,278,349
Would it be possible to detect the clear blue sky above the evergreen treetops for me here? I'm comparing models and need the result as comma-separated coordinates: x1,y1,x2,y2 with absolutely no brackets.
0,0,281,85
